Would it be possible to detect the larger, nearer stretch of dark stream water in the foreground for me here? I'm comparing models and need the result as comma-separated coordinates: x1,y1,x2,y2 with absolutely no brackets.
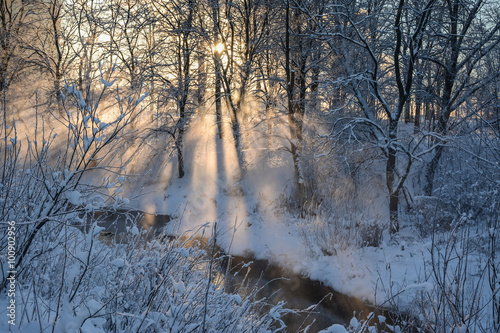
223,254,393,332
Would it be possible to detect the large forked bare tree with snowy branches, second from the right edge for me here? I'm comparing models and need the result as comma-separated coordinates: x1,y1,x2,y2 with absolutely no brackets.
306,0,436,233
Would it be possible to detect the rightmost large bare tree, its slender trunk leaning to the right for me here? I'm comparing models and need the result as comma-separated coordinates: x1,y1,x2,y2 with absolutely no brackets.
421,0,500,195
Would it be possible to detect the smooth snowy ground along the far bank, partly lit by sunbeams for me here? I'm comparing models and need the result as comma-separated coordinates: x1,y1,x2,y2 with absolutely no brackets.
100,115,491,326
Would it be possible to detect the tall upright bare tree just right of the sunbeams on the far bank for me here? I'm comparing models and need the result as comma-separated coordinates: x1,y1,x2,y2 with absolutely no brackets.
282,0,326,201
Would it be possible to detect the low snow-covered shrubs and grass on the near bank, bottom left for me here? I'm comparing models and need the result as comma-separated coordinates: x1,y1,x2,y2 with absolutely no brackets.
4,221,287,332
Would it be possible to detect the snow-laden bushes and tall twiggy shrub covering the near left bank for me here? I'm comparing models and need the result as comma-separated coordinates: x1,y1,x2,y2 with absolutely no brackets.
0,74,289,332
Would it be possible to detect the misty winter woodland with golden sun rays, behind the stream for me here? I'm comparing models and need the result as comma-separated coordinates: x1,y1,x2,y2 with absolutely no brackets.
0,0,500,331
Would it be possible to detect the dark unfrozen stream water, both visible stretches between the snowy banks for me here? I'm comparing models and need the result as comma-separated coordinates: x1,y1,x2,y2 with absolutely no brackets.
87,210,406,332
